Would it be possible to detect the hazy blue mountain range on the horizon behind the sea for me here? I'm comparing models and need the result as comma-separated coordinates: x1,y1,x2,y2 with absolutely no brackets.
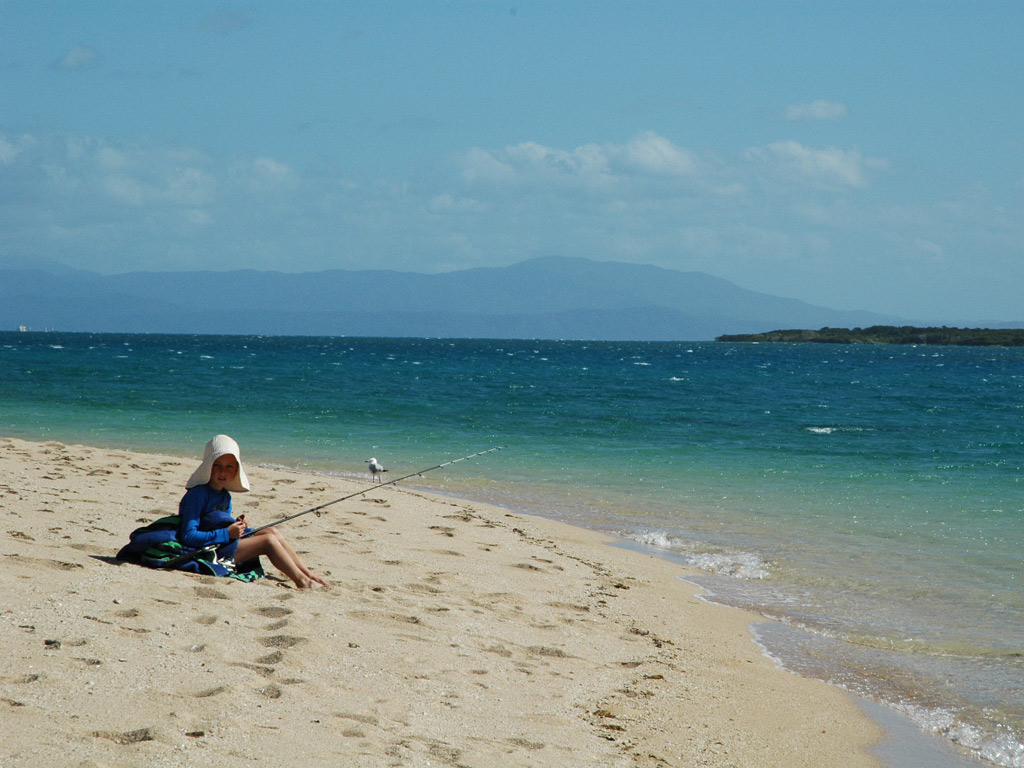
6,257,905,341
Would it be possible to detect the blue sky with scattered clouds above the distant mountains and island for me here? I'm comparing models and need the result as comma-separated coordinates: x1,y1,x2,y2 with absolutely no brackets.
0,0,1024,325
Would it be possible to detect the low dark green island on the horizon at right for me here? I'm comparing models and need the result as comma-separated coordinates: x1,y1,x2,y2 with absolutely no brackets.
715,326,1024,347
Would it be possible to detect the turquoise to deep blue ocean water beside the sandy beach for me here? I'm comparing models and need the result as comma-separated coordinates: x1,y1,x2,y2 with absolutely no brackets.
0,333,1024,767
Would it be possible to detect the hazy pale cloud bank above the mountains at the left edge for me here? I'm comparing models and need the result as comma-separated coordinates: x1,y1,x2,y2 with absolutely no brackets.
0,133,302,270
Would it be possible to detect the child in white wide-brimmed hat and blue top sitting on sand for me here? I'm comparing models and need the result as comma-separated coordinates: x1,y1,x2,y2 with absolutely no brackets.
178,434,327,589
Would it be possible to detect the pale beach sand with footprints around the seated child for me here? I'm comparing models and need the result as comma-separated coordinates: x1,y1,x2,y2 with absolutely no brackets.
0,439,883,768
